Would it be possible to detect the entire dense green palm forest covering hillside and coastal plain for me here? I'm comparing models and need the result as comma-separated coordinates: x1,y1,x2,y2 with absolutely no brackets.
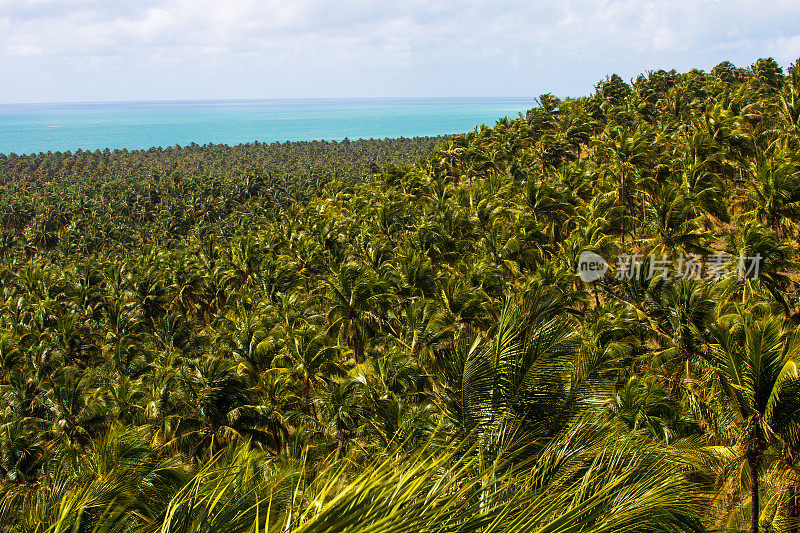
0,59,800,533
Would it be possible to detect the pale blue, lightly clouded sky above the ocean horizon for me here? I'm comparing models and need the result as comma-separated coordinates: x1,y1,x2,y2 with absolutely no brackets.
0,0,800,103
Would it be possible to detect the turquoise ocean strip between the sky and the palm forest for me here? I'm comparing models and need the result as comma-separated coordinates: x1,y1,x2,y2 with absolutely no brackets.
0,98,534,154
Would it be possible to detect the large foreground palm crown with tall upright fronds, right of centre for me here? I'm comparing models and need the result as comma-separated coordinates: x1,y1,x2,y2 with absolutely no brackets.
432,290,580,447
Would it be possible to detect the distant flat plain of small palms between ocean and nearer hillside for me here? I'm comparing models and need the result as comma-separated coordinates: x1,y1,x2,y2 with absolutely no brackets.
0,136,446,255
